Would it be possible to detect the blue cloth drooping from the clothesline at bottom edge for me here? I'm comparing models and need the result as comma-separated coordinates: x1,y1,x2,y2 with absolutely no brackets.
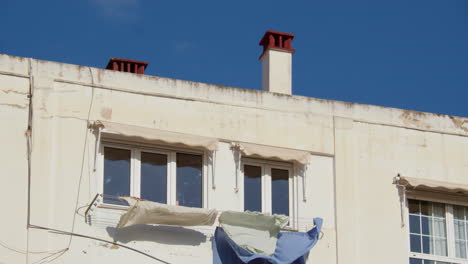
212,218,323,264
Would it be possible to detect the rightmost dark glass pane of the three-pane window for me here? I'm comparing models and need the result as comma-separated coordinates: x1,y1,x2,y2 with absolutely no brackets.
176,153,203,208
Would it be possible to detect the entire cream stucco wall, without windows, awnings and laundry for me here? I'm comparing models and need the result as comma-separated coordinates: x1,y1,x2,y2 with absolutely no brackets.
0,55,468,264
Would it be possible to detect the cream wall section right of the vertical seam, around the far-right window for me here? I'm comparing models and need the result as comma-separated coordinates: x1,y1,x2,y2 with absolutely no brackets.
335,119,468,264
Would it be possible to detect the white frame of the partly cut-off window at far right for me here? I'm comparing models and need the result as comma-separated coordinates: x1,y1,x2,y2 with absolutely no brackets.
405,195,468,264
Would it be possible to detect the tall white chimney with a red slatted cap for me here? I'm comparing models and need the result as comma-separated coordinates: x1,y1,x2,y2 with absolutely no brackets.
259,30,294,94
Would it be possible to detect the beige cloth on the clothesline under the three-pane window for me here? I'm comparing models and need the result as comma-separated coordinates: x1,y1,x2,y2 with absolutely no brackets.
117,197,218,228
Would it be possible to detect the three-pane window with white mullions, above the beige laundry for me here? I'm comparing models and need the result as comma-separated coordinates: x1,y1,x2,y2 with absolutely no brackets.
101,143,204,207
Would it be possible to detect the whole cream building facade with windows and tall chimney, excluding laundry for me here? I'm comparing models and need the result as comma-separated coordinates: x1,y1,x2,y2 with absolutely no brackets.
0,32,468,264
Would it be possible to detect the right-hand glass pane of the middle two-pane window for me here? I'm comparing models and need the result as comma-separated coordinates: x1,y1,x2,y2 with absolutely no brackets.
271,169,289,215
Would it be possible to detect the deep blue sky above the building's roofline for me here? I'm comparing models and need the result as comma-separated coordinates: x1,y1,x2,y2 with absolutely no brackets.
0,0,468,117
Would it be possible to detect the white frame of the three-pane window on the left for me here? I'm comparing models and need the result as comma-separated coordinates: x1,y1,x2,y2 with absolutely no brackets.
96,140,208,209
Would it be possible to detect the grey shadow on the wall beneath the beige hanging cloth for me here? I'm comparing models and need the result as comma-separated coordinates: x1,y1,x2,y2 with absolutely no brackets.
106,225,206,246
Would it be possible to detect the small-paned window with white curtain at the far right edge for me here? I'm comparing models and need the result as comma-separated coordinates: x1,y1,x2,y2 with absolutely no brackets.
408,200,468,264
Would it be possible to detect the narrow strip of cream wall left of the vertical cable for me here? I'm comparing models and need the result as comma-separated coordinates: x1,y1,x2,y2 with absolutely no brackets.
0,72,29,264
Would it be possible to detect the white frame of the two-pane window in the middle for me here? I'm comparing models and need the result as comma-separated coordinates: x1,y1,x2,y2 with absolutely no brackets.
239,158,297,228
